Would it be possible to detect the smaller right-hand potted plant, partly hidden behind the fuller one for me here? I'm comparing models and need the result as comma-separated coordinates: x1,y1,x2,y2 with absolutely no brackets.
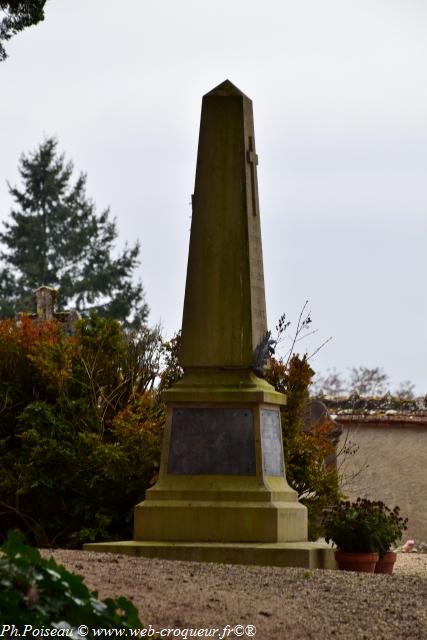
375,502,408,574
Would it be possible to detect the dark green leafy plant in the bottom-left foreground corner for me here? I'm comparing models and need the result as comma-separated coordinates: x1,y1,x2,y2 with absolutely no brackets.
0,532,142,638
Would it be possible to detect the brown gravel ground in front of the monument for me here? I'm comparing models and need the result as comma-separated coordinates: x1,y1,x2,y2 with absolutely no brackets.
44,550,427,640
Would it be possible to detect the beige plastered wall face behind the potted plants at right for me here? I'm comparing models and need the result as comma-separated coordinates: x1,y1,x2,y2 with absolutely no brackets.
335,415,427,542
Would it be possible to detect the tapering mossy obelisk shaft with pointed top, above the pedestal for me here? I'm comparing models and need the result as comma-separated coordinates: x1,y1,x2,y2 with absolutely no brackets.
180,80,267,368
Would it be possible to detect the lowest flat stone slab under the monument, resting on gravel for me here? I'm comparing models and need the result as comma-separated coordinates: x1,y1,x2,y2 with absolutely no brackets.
83,540,337,569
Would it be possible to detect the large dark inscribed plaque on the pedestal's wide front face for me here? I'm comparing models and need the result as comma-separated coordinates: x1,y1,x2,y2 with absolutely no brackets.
168,409,256,476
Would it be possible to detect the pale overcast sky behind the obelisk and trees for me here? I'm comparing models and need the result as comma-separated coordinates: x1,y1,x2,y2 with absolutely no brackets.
0,0,427,393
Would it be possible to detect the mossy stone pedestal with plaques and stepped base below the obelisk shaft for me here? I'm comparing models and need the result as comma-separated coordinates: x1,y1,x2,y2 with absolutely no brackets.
84,371,336,569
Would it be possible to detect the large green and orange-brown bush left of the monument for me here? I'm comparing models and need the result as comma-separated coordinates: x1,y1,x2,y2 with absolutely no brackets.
0,315,165,547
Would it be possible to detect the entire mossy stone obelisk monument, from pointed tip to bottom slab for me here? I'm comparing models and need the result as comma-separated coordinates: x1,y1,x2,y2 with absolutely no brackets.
87,80,335,568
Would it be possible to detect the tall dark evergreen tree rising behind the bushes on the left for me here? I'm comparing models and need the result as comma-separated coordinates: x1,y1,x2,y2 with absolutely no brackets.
0,138,148,324
